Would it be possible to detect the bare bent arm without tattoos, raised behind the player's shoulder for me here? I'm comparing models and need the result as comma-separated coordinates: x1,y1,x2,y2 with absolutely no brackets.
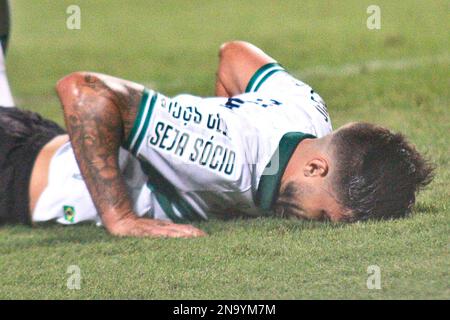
216,41,275,97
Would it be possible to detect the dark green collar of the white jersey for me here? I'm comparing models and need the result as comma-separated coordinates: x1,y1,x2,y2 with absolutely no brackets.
255,132,315,212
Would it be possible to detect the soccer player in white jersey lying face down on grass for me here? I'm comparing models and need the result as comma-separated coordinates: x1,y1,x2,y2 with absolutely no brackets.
0,41,432,237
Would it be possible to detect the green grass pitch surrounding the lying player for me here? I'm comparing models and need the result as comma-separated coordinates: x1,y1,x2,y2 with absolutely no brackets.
0,0,450,299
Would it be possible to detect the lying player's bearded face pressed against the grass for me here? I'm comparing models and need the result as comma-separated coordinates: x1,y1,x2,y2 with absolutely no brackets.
275,182,346,221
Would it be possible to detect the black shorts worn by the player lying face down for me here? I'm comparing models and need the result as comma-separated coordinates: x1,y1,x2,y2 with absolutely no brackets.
0,107,65,225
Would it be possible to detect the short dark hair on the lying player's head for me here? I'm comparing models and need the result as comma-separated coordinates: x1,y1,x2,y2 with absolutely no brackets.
331,122,434,221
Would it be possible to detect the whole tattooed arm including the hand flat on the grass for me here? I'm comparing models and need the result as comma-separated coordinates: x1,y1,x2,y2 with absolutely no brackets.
56,72,204,237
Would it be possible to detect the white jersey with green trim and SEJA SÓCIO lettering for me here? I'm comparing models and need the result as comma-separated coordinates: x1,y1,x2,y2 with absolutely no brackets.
33,63,331,224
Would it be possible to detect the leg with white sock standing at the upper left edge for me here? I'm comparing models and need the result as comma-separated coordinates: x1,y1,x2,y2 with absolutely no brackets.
0,0,14,107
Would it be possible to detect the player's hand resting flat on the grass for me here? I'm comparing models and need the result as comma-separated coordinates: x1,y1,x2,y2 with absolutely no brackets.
108,217,207,238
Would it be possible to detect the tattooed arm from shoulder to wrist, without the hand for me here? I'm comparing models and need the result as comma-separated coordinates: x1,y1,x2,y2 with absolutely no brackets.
60,74,142,228
